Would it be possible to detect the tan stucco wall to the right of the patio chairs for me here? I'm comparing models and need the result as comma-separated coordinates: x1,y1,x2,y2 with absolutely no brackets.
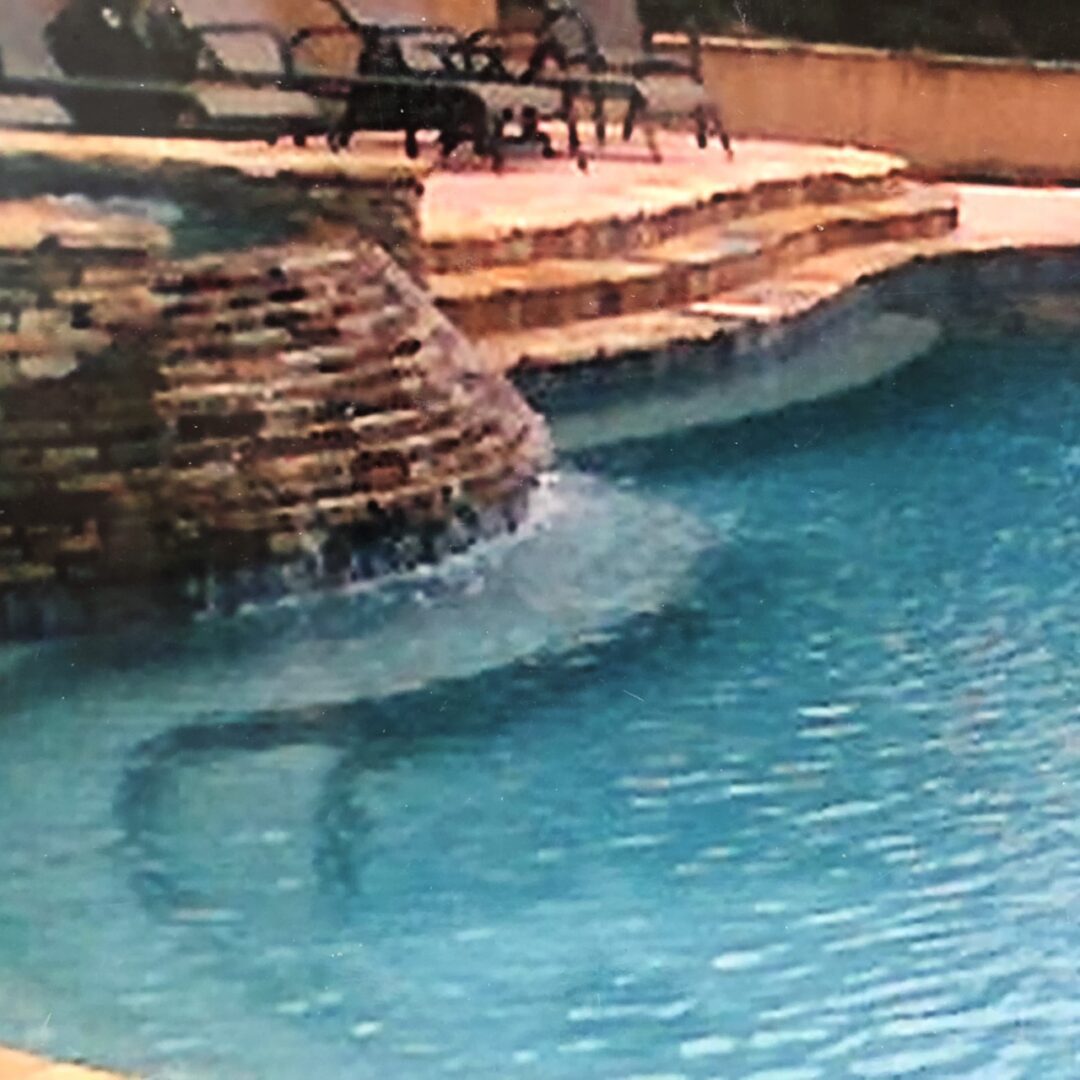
669,38,1080,179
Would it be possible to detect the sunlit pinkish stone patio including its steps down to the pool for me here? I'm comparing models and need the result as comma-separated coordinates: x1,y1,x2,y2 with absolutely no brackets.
401,133,1080,370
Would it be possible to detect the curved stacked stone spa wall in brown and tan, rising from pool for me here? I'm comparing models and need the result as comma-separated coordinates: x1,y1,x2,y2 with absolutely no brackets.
0,145,548,636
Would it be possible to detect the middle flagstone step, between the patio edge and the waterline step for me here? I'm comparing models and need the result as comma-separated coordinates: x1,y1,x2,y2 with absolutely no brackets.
431,185,957,340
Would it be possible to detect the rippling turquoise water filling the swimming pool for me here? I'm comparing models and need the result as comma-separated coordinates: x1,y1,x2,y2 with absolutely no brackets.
0,324,1080,1080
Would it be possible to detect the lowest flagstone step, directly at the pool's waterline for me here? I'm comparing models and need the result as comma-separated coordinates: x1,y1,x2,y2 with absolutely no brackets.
478,237,955,372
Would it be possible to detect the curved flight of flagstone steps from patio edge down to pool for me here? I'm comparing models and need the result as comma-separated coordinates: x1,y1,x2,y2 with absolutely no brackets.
429,174,957,370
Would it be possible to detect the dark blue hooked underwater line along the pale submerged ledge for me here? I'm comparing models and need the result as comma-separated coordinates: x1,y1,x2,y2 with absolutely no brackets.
113,574,730,920
